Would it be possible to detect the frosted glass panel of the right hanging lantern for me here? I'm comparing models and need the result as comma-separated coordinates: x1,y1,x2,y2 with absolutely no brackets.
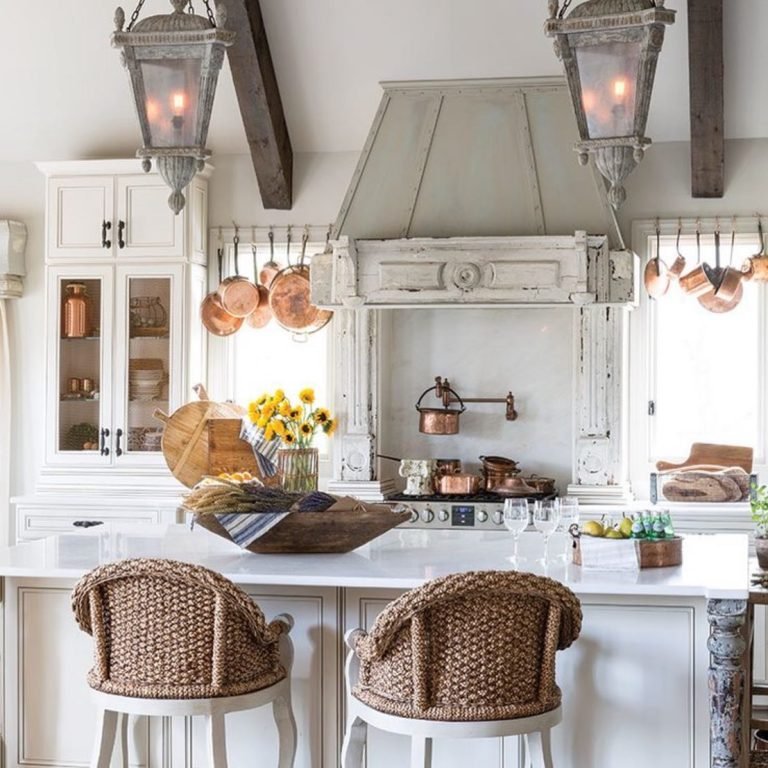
576,42,641,139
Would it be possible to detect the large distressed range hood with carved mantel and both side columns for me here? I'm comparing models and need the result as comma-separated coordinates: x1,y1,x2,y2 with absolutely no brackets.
318,78,638,501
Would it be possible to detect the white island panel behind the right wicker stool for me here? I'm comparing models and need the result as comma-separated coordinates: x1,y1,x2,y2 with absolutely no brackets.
345,590,709,768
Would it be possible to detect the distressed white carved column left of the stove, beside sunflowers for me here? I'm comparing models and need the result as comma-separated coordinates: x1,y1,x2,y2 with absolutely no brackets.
328,309,394,501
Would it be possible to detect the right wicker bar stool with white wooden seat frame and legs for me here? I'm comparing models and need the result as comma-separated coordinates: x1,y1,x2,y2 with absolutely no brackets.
341,571,582,768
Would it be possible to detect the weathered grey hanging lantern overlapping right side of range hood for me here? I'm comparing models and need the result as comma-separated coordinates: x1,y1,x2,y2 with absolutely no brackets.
544,0,675,208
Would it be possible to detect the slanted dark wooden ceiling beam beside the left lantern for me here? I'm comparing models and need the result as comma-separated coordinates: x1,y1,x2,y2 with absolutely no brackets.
227,0,293,210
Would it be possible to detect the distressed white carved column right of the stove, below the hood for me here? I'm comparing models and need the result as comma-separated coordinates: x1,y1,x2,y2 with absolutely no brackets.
568,304,632,503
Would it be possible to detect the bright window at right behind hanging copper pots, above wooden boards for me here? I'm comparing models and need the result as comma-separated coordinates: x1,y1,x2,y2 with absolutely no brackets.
629,220,768,495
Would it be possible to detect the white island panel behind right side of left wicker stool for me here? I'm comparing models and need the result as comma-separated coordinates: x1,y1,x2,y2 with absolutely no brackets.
184,586,341,768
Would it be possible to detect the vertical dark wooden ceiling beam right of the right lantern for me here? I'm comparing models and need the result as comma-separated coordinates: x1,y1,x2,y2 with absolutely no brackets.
688,0,725,197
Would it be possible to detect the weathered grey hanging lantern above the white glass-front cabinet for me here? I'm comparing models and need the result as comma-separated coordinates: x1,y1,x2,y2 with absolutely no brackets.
112,0,235,213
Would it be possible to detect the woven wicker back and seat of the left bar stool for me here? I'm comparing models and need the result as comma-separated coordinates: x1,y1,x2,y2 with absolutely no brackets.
72,559,287,699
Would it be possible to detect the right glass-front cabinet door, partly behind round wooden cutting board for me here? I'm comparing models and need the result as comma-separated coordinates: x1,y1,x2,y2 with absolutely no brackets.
112,265,184,465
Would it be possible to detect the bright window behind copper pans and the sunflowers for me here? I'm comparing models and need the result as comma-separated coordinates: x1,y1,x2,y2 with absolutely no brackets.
211,227,335,457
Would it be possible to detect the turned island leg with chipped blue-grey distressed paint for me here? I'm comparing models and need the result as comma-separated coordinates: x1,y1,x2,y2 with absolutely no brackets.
707,600,747,768
